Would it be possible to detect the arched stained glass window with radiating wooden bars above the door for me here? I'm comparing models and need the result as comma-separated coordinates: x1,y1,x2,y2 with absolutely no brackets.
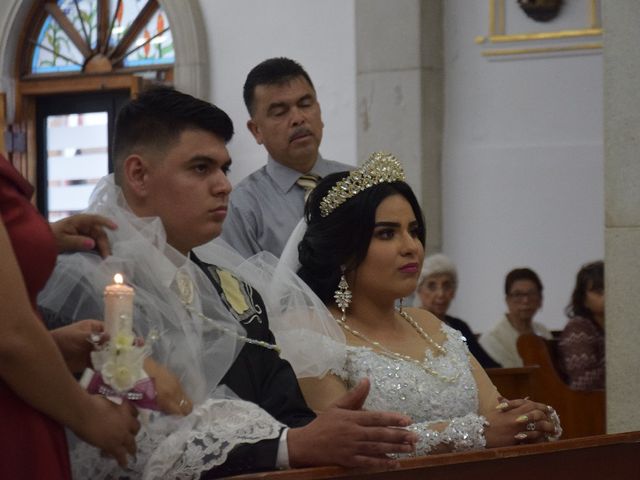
27,0,175,74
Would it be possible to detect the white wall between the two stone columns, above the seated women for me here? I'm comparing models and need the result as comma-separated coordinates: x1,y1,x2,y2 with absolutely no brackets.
442,0,604,331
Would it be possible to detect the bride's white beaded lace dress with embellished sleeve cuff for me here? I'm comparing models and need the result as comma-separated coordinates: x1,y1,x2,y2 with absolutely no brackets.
332,323,486,455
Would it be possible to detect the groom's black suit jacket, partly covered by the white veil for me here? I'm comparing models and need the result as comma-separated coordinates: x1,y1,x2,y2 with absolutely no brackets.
191,254,315,479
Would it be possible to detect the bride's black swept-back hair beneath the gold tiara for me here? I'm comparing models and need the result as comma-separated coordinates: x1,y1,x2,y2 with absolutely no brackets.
298,172,425,303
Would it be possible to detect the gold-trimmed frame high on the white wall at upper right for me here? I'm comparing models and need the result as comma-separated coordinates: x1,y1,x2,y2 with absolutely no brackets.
475,0,602,58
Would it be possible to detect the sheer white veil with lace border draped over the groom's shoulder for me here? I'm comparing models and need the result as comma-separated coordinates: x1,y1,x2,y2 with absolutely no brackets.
38,176,282,478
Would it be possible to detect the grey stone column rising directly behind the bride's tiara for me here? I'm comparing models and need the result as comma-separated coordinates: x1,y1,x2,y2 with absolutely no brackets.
355,0,444,252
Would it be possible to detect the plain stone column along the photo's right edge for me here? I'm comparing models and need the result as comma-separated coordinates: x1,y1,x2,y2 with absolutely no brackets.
601,0,640,433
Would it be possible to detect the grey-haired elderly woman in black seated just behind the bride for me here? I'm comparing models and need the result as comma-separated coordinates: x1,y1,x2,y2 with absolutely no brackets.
415,253,500,368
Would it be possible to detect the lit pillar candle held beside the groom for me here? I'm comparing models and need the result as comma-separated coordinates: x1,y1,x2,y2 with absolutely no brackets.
104,273,134,339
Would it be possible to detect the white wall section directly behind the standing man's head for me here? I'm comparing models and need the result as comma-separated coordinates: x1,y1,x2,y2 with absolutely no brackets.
200,0,357,184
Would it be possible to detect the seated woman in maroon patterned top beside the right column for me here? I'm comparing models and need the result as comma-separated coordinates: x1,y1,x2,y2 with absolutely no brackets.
558,261,605,390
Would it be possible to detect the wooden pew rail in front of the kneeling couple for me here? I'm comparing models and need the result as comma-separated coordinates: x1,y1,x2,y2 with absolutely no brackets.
232,432,640,480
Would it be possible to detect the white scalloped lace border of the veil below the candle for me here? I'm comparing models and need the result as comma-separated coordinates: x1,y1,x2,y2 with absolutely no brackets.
71,399,284,480
